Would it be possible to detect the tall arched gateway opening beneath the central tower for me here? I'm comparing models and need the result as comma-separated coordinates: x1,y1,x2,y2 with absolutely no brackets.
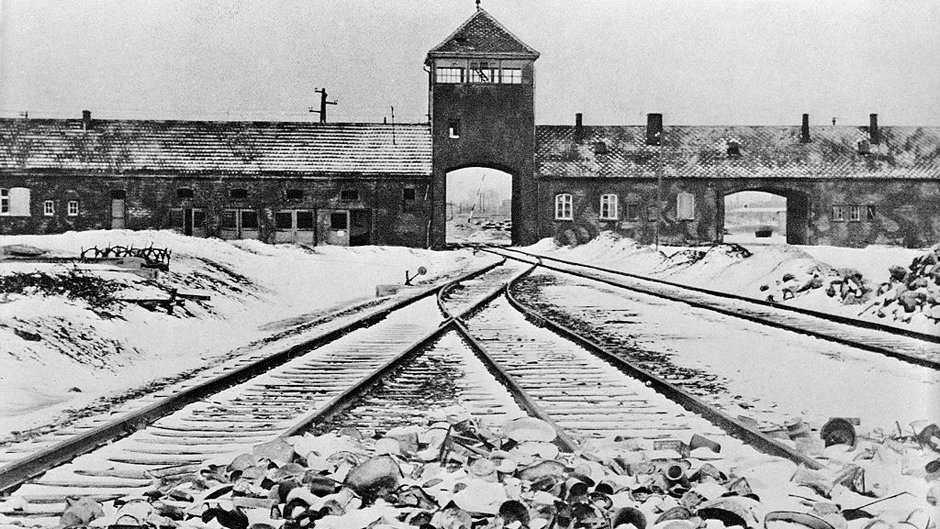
446,167,513,246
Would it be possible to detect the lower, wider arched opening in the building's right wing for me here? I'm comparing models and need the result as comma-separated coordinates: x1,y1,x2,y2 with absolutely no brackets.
722,189,809,244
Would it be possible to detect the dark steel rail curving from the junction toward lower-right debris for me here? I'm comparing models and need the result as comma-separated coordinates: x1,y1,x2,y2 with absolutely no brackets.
506,261,822,469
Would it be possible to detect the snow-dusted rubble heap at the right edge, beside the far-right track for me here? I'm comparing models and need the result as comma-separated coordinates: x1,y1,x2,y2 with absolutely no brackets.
861,244,940,323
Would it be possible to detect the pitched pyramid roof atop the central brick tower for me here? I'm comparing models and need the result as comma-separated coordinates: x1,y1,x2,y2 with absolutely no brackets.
427,7,539,62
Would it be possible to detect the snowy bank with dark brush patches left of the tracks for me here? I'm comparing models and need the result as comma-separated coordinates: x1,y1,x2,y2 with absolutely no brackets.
0,231,482,437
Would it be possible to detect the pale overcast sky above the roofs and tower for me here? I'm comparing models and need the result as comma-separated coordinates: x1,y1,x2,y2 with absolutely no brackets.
0,0,940,125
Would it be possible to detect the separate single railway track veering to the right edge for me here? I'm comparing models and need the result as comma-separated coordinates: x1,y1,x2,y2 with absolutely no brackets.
484,247,940,369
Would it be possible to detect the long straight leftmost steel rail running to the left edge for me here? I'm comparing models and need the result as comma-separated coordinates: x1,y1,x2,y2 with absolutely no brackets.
0,257,506,492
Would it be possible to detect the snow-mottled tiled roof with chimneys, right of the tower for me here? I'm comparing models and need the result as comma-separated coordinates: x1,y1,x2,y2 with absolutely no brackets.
536,125,940,179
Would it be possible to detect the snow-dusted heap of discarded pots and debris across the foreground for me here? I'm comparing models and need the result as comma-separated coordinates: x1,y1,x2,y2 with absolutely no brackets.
0,416,940,529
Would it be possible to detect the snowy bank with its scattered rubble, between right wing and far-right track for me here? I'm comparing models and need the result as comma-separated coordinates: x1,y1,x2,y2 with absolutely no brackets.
527,232,940,334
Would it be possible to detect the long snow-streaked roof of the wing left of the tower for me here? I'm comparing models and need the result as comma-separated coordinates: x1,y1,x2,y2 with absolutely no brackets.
0,119,431,176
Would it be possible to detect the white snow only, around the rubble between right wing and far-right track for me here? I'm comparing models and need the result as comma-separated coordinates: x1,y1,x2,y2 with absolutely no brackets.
526,232,940,333
